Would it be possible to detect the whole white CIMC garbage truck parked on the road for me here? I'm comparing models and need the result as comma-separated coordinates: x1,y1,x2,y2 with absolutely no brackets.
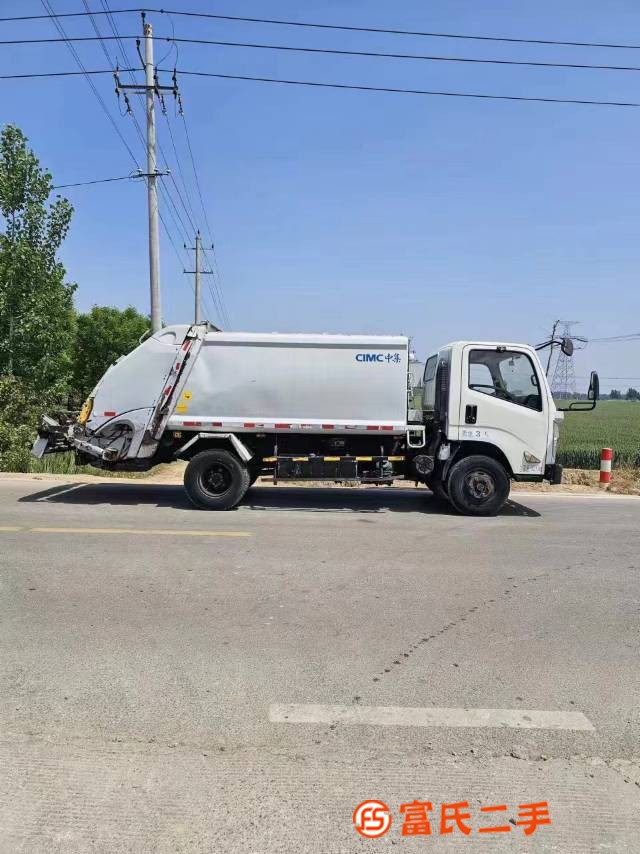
33,324,598,516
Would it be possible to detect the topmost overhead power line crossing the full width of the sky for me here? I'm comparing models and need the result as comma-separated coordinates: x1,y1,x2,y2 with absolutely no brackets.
0,6,640,50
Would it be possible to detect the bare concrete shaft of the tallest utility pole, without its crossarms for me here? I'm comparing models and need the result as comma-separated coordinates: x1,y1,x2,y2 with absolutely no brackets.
143,23,162,332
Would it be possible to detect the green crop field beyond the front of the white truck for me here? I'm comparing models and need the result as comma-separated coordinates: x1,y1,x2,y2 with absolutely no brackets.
558,400,640,469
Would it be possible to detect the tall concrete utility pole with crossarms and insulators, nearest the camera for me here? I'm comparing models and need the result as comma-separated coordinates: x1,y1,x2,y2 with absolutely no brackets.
114,12,178,333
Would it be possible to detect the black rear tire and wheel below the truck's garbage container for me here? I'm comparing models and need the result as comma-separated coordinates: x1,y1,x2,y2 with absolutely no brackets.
184,449,250,510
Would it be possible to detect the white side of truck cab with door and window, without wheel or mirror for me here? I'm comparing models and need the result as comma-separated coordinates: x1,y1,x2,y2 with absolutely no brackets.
459,344,549,482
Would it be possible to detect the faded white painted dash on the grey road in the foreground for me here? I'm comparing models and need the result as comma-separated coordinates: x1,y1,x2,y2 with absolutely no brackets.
269,703,595,731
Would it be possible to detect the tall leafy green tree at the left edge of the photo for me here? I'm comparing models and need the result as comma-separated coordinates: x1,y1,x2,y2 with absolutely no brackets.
0,125,76,403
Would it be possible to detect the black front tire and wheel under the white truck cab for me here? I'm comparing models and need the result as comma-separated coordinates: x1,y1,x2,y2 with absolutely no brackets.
447,454,511,516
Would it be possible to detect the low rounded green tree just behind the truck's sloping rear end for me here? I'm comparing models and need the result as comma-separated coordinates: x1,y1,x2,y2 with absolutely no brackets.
73,305,150,402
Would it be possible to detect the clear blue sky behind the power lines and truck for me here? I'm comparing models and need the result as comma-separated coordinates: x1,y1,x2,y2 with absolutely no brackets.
0,0,640,389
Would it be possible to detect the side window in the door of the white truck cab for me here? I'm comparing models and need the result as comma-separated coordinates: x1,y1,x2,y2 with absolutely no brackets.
469,350,542,411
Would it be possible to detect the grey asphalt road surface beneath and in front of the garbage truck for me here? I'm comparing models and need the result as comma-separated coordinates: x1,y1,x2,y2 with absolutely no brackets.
0,480,640,854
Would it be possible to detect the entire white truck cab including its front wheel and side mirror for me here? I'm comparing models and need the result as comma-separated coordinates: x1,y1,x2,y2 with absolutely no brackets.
422,341,597,515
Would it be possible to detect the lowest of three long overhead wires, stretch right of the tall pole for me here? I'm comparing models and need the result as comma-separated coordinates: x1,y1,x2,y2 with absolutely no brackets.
169,69,640,107
